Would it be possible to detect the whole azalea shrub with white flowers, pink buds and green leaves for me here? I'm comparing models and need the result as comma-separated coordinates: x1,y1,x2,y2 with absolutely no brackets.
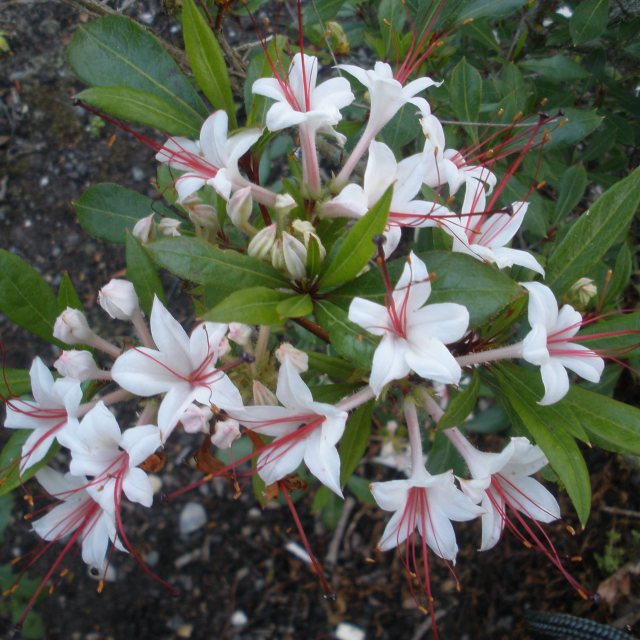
0,0,640,635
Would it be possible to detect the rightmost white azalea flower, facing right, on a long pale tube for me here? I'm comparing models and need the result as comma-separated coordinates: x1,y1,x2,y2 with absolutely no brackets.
521,282,604,405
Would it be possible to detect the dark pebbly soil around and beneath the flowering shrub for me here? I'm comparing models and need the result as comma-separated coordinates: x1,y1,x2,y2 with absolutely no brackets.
0,0,640,640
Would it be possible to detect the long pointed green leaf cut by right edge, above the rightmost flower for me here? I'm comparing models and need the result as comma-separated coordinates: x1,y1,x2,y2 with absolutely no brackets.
546,169,640,295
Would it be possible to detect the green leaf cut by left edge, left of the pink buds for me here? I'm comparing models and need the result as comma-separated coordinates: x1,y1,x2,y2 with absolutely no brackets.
0,249,61,348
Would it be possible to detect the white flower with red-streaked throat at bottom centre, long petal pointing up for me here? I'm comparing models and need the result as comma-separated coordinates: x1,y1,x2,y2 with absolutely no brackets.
227,358,347,496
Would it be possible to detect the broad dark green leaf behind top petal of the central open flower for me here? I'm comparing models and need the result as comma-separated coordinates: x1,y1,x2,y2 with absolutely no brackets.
329,251,524,328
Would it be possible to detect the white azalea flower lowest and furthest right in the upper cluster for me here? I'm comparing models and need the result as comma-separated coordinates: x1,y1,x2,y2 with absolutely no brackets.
441,178,544,276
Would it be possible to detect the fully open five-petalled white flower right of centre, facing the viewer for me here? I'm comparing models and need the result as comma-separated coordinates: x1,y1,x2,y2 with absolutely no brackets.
349,252,469,396
